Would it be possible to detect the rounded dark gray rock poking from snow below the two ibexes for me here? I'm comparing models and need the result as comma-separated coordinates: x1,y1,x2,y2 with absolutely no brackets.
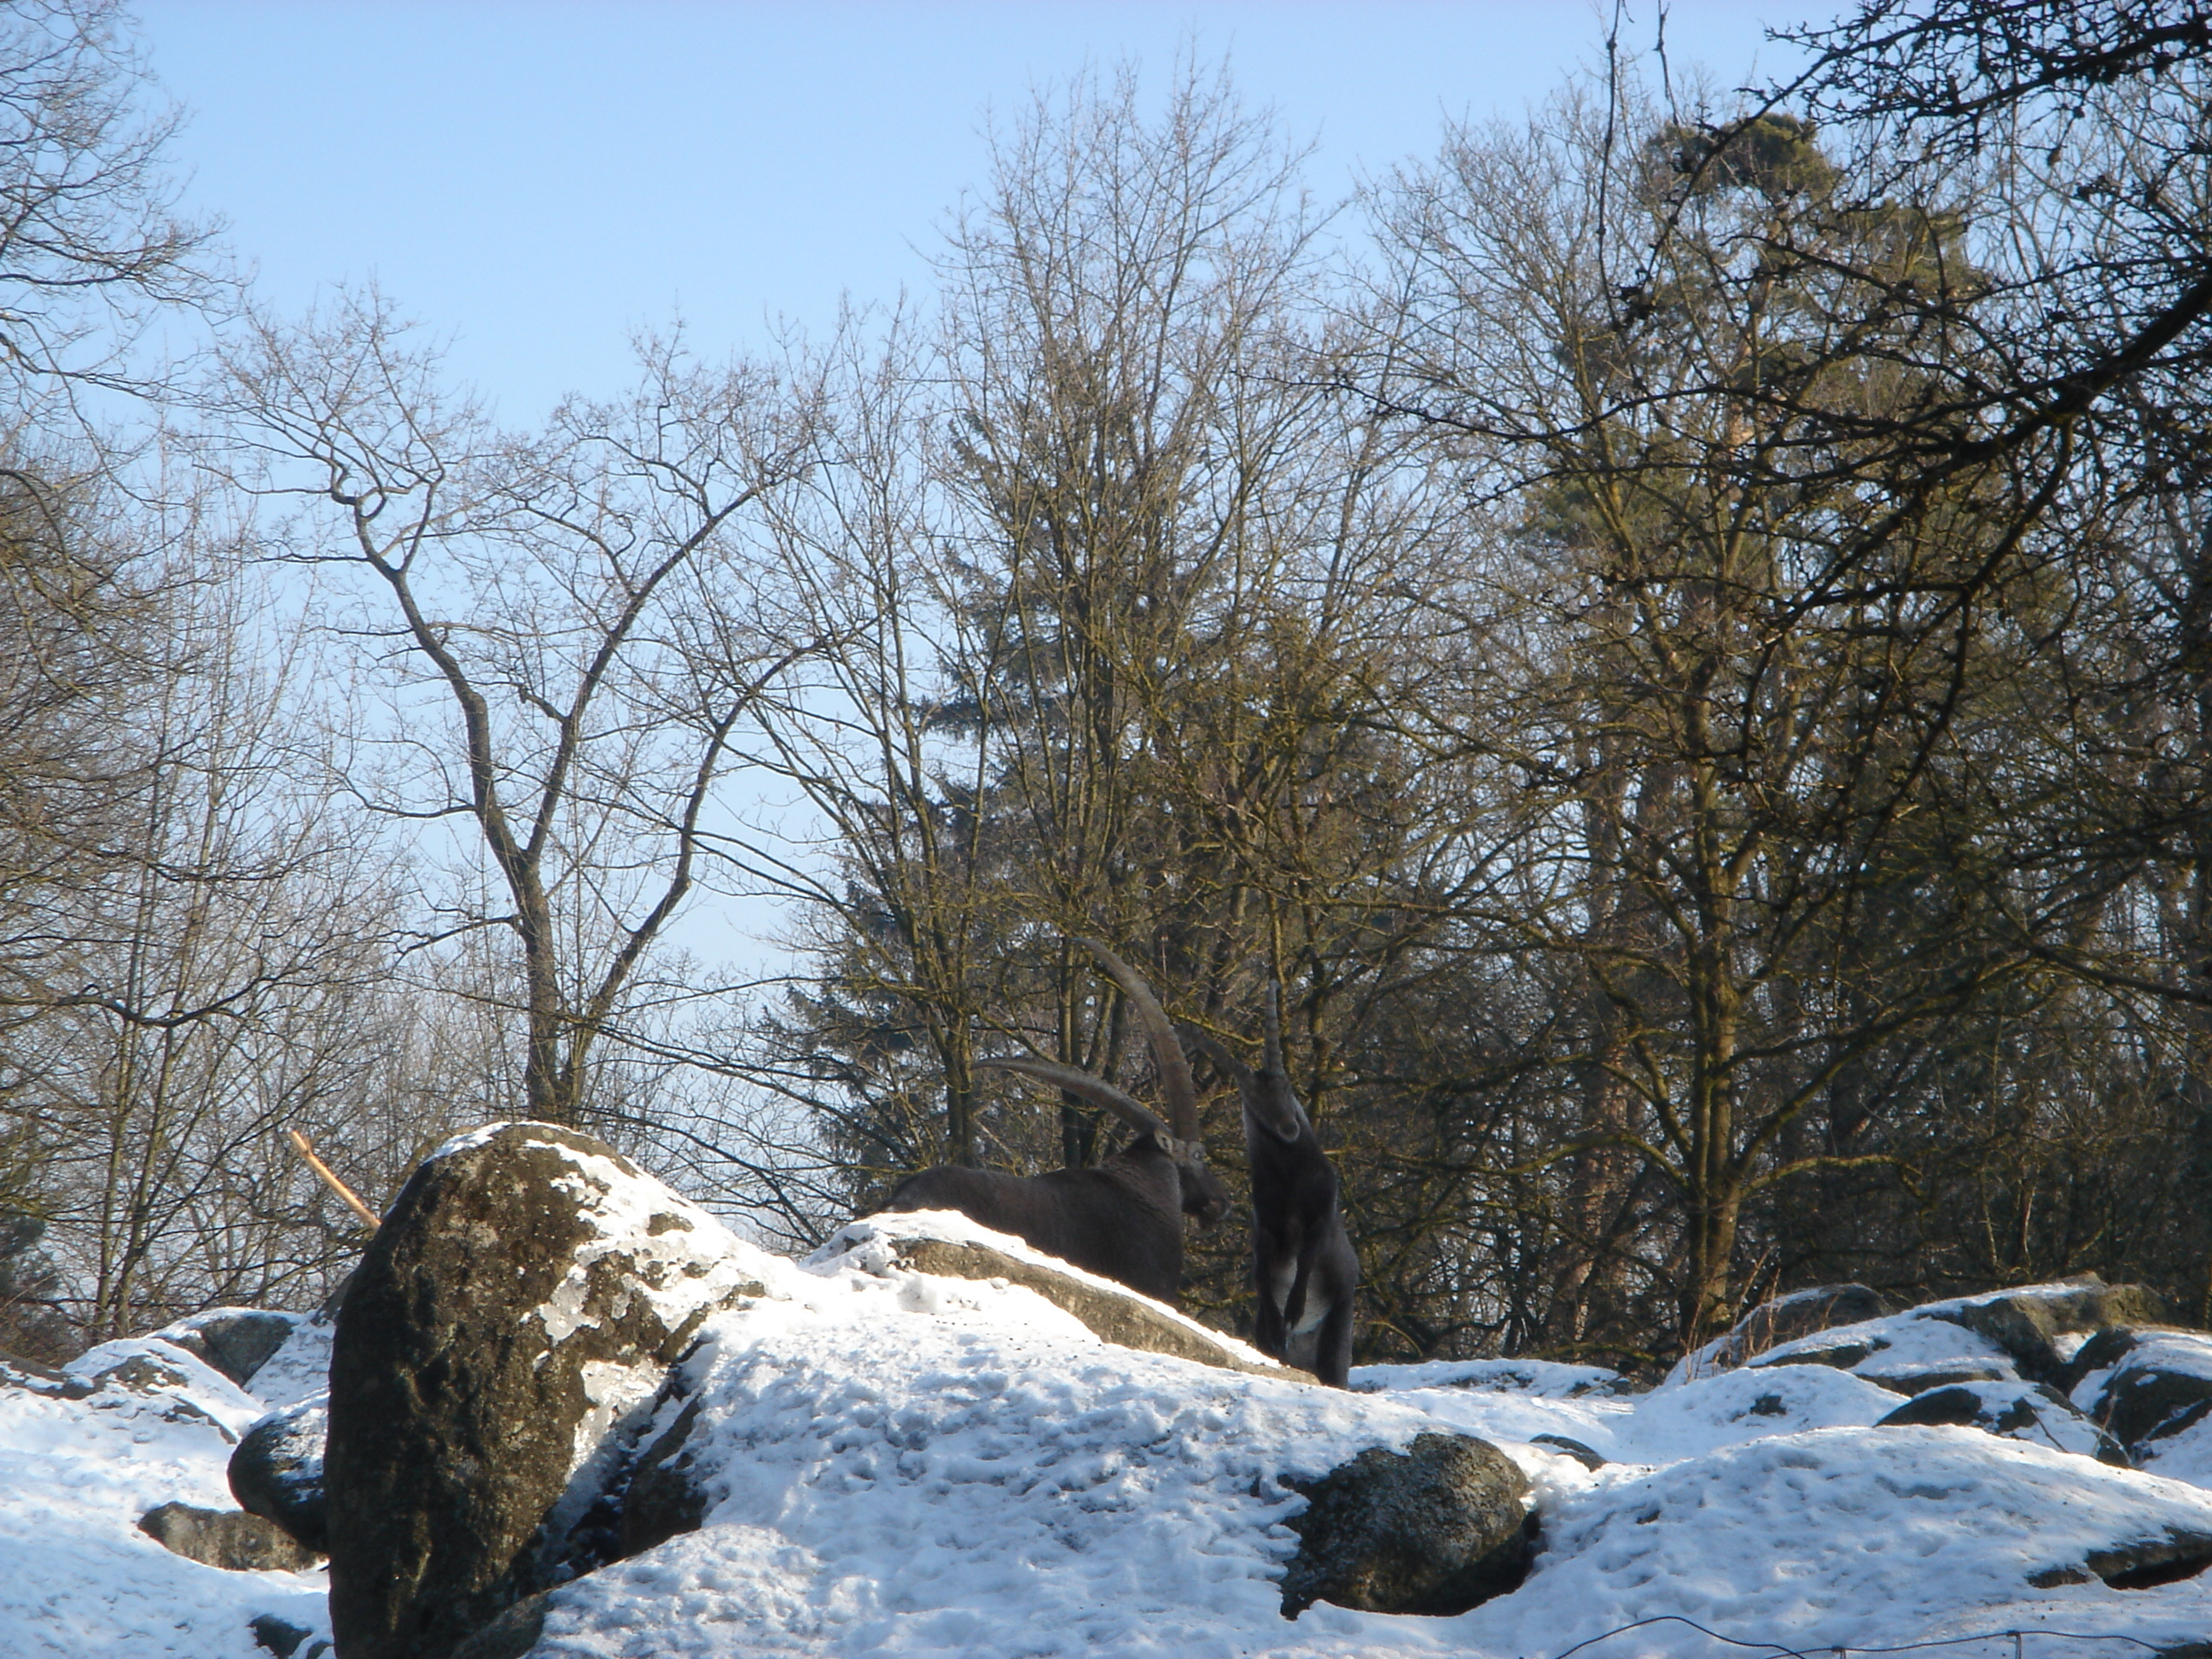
1283,1434,1535,1619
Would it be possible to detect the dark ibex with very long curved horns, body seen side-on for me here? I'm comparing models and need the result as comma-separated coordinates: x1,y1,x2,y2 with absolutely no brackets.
887,940,1230,1307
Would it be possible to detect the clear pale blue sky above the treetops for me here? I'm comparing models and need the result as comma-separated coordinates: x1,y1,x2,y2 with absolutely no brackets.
137,0,1796,422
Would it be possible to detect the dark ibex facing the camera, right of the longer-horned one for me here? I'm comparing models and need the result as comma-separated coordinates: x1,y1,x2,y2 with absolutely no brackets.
1184,987,1360,1389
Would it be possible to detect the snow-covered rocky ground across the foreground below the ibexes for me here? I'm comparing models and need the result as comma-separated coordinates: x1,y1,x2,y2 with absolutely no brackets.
0,1217,2212,1659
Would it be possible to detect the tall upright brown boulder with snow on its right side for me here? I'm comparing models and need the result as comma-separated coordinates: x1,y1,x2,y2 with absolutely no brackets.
323,1124,761,1659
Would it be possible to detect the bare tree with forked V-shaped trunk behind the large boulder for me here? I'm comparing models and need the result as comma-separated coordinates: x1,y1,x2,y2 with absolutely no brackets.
221,296,810,1121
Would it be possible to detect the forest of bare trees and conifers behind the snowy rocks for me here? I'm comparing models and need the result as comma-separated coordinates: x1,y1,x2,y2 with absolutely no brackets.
0,0,2212,1369
